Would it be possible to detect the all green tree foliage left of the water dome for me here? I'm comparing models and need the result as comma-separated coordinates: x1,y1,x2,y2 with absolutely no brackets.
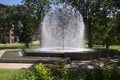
0,0,50,47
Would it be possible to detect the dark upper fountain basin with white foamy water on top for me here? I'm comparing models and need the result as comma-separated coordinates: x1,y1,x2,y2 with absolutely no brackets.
23,49,117,60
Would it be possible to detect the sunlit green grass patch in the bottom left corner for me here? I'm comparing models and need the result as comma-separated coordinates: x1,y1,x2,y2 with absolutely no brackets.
0,69,24,80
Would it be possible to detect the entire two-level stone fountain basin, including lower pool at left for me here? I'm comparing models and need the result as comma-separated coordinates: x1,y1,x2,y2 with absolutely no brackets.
0,49,120,63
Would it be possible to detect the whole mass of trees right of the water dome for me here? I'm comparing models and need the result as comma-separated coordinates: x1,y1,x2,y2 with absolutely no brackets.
59,0,119,48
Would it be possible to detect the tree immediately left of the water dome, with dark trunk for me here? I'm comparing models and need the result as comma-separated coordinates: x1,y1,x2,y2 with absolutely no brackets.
21,0,49,47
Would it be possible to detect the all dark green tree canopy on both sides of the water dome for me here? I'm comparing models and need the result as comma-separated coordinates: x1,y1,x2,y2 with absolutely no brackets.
0,0,120,48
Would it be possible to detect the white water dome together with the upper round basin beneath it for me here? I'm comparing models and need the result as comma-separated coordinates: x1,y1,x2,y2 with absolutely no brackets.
24,4,93,57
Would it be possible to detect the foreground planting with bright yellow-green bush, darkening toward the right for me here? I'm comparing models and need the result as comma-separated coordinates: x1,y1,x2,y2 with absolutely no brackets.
15,62,120,80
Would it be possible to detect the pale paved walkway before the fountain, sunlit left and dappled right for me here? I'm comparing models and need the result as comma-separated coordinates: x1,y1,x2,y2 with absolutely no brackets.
0,59,119,69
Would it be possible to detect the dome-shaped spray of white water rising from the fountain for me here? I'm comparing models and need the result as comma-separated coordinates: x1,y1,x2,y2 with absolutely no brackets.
40,4,84,49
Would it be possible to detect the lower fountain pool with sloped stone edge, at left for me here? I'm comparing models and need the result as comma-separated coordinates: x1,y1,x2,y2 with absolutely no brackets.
0,50,69,64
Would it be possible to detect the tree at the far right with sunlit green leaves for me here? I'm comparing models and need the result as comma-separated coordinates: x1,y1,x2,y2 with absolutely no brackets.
95,0,119,49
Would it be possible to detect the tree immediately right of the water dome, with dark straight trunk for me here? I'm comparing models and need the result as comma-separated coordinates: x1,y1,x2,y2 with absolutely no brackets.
59,0,107,48
